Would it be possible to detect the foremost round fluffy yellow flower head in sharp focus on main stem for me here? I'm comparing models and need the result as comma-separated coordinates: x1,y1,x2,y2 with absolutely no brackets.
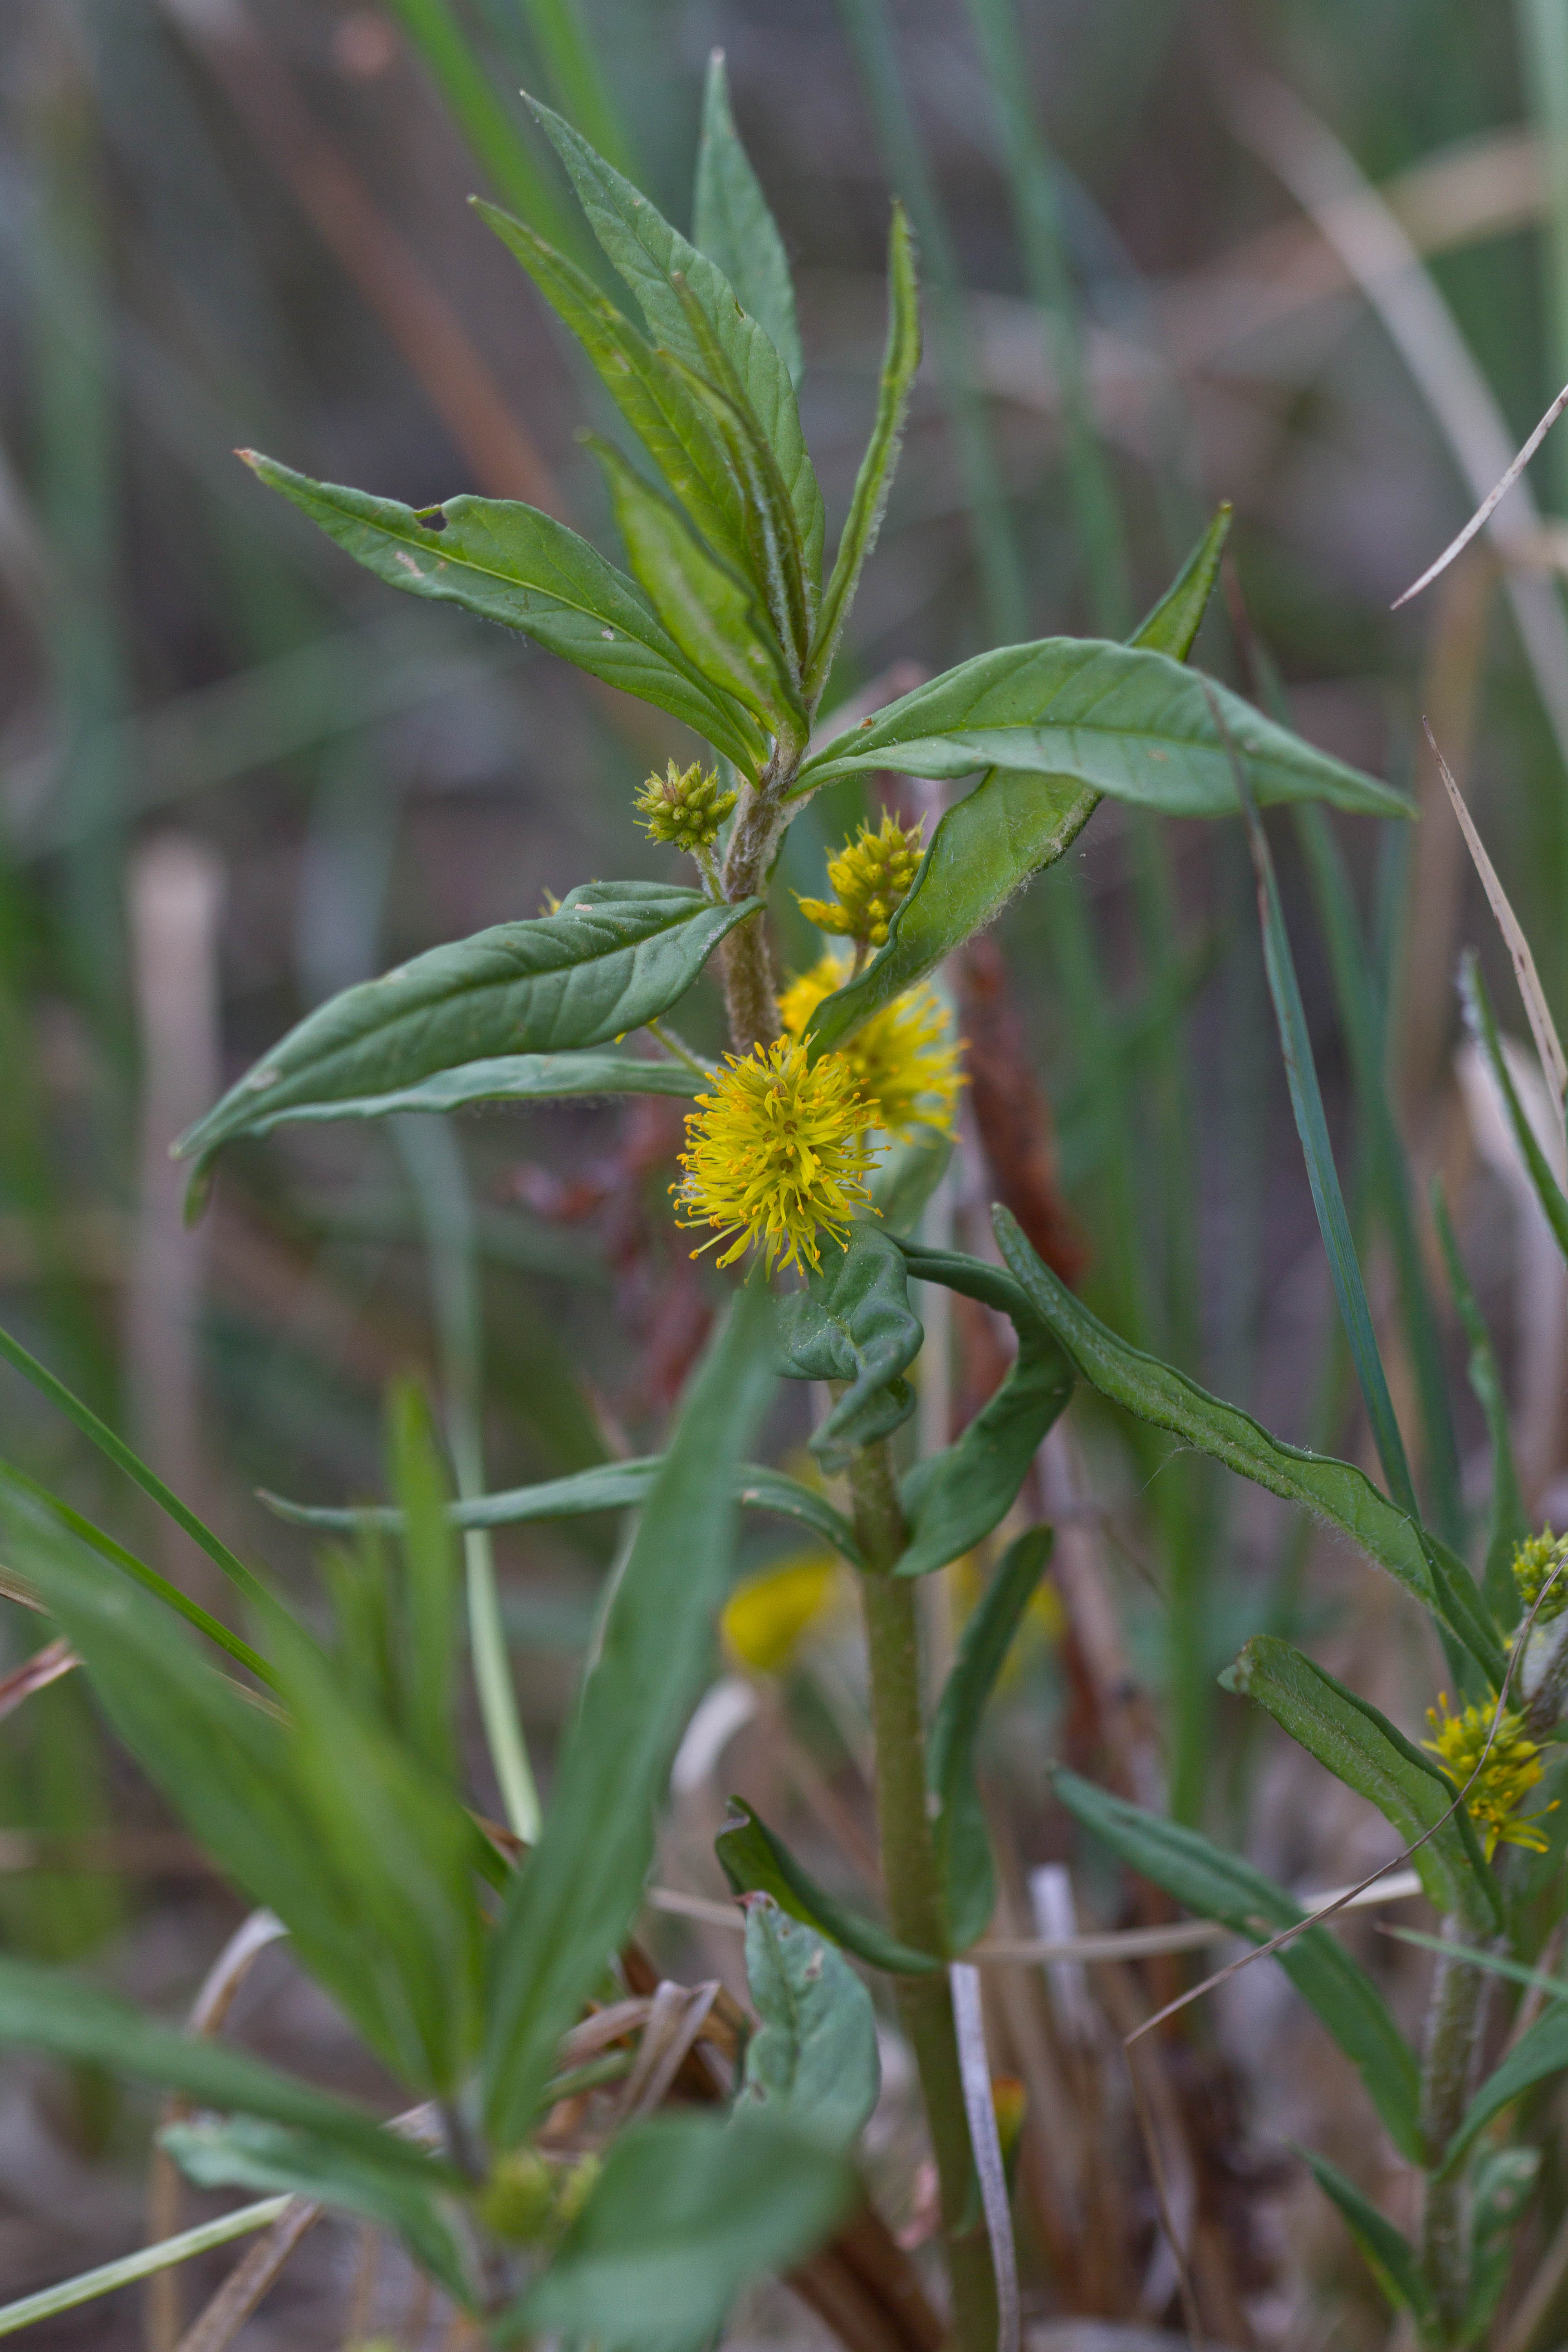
670,1037,877,1273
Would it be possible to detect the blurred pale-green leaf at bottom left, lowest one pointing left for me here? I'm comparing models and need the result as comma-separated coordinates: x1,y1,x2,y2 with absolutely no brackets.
157,2117,475,2310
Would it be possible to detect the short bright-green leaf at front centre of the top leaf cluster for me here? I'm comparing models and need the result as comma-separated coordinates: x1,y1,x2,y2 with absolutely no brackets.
590,440,804,734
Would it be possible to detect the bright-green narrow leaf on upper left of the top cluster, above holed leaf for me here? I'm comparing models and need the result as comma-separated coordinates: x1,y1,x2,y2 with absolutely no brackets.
475,200,745,572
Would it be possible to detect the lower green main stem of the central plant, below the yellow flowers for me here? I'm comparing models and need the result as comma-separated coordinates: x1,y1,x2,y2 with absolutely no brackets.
848,1442,997,2352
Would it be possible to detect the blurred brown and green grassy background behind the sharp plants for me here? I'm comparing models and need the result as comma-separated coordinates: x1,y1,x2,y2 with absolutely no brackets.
0,0,1568,2352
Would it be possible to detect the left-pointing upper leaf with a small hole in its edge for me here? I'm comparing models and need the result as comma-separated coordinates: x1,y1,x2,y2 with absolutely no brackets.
242,449,762,774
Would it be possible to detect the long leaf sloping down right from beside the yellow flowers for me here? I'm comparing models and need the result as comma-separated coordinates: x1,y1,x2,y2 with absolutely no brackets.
992,1209,1436,1609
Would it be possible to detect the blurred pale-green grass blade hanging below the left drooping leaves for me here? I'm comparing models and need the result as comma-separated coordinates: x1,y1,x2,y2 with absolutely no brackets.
397,1117,541,1846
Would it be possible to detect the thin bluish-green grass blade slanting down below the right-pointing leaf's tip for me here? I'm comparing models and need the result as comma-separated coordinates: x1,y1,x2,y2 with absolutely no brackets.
1210,696,1420,1519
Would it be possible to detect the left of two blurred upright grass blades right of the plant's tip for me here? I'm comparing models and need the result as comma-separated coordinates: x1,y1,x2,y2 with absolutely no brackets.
839,0,1025,644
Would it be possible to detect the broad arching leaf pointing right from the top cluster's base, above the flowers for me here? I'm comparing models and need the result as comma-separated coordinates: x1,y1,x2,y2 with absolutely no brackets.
794,637,1411,816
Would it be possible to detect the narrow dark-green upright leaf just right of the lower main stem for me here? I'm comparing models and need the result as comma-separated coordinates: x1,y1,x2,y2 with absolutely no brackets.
926,1526,1051,1952
